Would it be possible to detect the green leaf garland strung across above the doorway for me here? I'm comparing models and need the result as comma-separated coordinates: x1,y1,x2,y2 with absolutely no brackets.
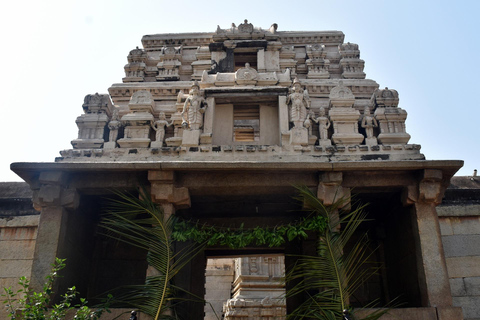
172,214,327,249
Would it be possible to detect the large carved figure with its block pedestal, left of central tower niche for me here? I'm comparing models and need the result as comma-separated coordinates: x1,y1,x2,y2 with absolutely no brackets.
182,81,207,146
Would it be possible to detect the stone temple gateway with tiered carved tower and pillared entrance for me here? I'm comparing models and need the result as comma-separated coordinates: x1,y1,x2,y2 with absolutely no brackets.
0,20,480,320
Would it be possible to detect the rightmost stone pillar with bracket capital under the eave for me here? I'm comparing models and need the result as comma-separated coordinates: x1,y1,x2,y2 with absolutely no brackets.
403,169,463,320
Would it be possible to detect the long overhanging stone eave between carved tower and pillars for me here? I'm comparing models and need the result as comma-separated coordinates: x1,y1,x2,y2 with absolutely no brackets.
10,160,463,182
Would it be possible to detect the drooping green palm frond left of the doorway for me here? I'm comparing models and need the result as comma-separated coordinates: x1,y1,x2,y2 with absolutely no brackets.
100,190,205,320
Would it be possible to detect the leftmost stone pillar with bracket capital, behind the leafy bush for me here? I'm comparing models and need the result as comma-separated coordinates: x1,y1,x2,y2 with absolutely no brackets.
30,172,79,291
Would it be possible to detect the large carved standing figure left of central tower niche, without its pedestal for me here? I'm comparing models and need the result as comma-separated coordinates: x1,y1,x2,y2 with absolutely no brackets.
182,81,207,130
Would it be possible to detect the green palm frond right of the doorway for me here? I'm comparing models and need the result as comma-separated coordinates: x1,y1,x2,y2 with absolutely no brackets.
286,188,388,320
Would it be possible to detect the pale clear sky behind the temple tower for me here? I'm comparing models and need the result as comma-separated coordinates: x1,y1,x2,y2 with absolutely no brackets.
0,0,480,181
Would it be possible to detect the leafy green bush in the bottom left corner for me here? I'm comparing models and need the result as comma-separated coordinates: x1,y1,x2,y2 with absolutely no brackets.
1,258,112,320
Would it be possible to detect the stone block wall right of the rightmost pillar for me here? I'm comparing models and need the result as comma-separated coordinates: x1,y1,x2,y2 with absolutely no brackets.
437,177,480,320
